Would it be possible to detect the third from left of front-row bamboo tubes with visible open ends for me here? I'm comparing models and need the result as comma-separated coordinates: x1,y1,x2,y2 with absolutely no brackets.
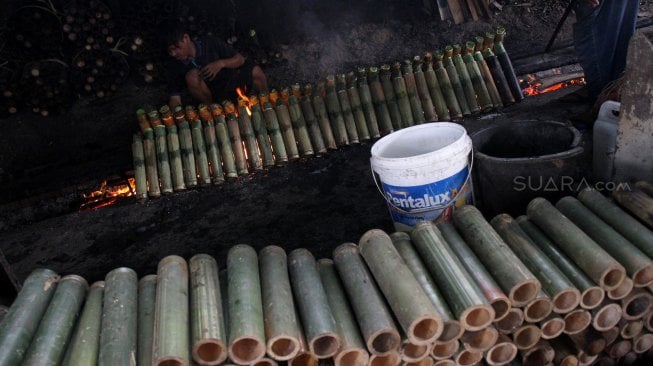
259,246,301,361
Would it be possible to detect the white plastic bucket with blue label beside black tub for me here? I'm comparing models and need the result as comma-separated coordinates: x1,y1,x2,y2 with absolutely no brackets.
370,122,472,231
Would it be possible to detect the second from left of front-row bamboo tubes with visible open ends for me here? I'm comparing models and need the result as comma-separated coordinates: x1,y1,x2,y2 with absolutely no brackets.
227,244,265,365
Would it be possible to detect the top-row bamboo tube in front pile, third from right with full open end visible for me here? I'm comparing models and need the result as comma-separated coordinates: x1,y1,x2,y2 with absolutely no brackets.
491,214,580,314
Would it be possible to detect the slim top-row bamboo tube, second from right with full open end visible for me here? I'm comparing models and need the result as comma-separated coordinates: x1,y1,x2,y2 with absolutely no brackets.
517,216,605,309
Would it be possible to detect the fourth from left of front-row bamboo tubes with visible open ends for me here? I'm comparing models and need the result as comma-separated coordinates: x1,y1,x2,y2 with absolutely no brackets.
288,249,340,359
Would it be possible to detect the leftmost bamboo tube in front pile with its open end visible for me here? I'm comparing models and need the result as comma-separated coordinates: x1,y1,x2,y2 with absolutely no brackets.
189,254,227,365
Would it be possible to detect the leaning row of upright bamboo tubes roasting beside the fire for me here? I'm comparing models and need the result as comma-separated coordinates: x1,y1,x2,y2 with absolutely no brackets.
132,28,523,199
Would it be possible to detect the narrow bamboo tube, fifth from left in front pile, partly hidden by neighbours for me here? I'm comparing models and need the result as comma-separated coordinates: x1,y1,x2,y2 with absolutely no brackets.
138,274,156,366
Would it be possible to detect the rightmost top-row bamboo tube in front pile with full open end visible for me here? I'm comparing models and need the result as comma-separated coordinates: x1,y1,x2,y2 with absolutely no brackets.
527,198,626,291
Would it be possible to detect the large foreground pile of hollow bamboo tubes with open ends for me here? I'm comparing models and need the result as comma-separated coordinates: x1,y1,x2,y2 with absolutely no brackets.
0,189,653,366
